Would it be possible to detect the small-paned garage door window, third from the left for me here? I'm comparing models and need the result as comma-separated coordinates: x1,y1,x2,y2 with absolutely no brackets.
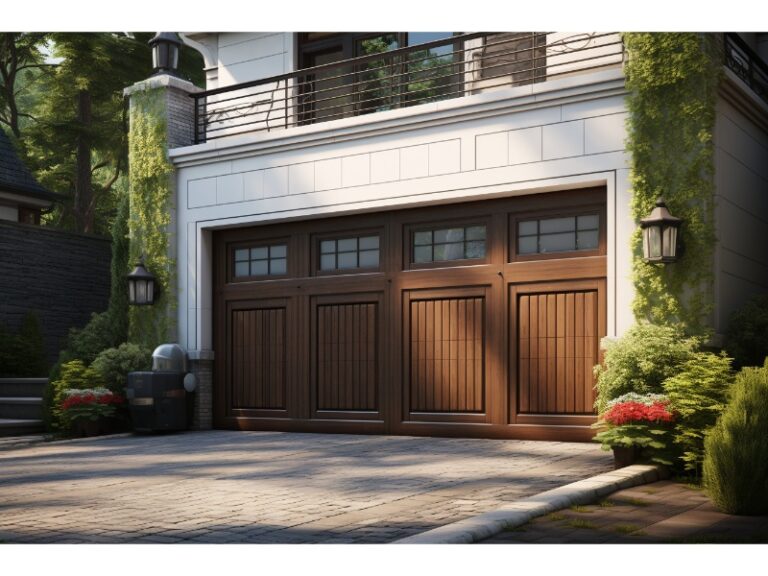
412,226,486,264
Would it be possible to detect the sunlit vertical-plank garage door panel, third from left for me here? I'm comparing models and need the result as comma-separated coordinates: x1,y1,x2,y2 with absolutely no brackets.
403,291,486,415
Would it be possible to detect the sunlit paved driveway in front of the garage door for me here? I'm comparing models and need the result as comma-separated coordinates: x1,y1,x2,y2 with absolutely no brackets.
0,431,611,543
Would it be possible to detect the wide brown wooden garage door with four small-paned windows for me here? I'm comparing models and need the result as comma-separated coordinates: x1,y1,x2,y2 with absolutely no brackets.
214,188,606,440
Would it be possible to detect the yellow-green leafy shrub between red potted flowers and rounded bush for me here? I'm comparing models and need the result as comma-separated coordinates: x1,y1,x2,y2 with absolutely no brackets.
664,352,734,477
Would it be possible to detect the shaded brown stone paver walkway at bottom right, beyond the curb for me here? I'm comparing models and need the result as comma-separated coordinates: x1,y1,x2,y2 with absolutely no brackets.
482,480,768,544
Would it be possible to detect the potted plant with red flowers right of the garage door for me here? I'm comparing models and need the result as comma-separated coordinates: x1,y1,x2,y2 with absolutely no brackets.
594,392,674,468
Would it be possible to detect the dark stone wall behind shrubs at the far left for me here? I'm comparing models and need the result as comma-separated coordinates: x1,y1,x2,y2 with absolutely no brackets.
0,220,112,368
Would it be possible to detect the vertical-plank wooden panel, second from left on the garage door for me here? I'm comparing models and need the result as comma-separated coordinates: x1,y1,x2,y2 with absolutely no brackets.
312,296,381,417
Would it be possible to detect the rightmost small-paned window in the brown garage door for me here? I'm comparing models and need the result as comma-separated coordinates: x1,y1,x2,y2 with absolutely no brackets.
517,214,600,255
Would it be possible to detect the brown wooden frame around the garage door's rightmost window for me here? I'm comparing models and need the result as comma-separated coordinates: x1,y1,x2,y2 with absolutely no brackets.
507,204,607,262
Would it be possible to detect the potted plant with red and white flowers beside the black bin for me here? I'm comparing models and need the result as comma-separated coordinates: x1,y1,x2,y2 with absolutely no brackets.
61,388,125,436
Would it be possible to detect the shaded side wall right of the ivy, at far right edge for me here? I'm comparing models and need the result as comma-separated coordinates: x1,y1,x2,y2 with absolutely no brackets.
715,72,768,335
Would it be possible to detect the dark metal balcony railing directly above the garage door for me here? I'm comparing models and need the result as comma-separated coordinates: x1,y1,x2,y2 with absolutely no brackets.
192,32,624,143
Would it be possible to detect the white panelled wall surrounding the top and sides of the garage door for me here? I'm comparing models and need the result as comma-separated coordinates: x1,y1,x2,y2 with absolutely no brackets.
171,66,635,350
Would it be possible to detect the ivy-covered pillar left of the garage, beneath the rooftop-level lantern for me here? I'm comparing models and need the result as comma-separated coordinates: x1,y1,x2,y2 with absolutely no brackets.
125,74,213,429
